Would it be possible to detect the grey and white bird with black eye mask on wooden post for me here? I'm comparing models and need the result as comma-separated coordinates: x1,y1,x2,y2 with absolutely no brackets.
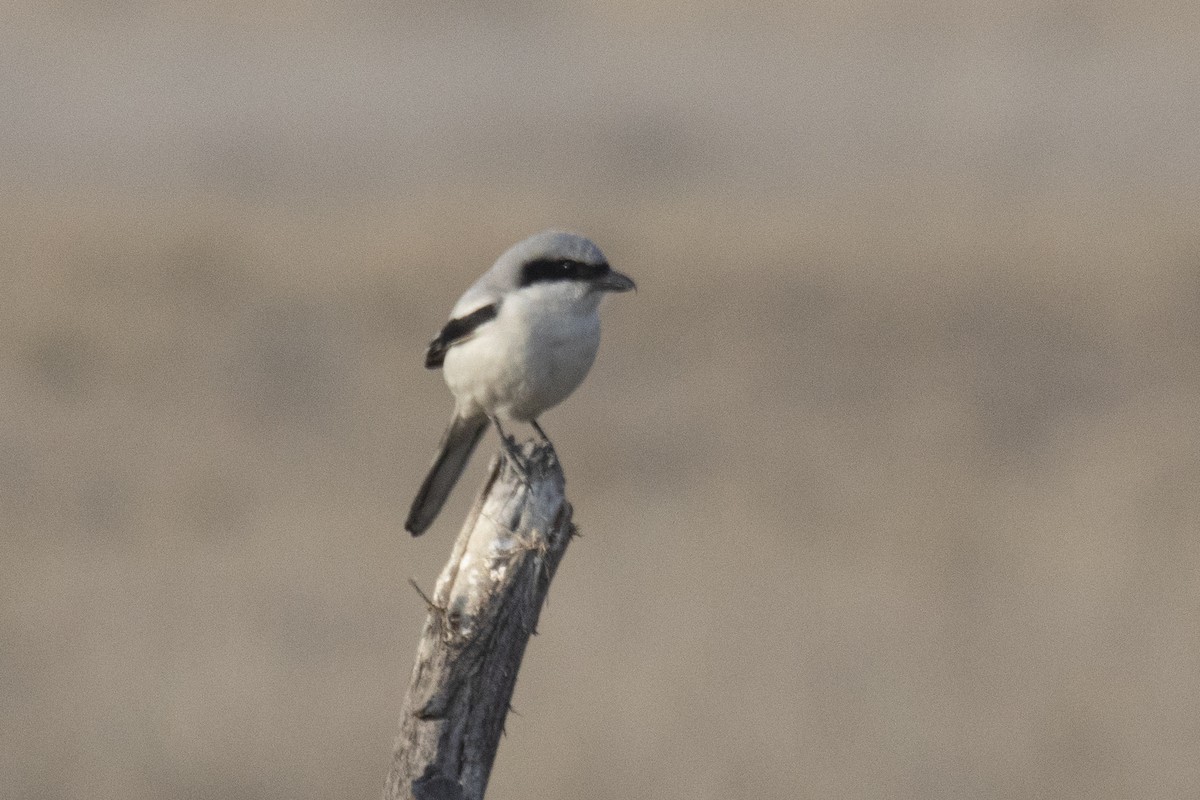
404,230,637,536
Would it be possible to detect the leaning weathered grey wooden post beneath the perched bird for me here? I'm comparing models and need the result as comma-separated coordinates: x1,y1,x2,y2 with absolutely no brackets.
384,443,575,800
